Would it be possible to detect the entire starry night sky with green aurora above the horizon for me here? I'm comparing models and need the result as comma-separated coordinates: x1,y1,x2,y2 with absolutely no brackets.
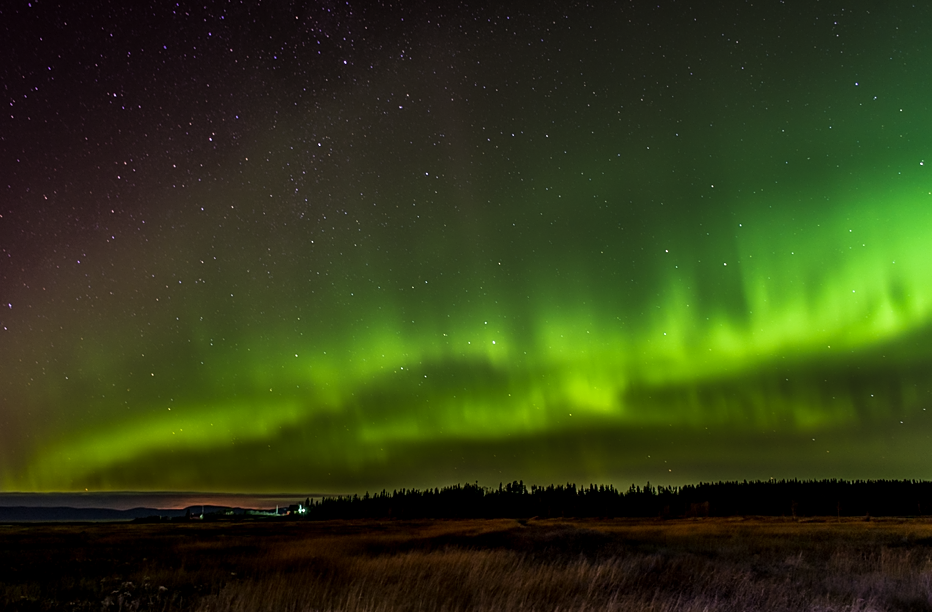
0,0,932,492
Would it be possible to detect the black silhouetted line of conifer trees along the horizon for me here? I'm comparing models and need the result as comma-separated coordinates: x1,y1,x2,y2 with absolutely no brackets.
304,480,932,520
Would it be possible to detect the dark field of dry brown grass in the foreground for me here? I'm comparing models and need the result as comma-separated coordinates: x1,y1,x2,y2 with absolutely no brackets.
0,519,932,612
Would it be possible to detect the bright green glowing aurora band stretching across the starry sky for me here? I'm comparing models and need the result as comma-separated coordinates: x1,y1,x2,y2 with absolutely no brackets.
15,178,932,488
